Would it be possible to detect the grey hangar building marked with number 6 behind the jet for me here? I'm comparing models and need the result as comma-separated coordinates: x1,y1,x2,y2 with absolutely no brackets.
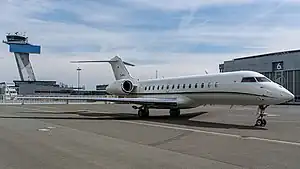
219,50,300,102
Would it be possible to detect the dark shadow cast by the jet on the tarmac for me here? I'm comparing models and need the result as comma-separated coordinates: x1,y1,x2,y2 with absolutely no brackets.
0,111,267,130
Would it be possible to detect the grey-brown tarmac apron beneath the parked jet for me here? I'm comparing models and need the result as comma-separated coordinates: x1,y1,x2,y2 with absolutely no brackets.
0,104,300,169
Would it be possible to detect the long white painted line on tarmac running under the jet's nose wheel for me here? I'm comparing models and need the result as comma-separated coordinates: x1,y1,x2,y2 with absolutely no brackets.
116,120,300,146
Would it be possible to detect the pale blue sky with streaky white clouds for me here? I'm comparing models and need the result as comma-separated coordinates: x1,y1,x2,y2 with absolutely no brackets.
0,0,300,89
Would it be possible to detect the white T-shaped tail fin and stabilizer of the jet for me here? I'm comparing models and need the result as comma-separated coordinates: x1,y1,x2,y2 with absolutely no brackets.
71,56,134,80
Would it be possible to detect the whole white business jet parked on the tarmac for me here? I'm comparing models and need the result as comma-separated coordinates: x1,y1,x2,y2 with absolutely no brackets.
16,56,294,127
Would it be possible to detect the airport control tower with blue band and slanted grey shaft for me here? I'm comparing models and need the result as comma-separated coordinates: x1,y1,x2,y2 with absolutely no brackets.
3,32,41,81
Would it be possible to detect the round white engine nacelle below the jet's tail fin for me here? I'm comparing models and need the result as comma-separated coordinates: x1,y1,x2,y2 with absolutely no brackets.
106,79,134,95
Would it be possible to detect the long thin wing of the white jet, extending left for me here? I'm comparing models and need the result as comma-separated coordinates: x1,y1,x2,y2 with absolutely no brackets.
16,96,177,106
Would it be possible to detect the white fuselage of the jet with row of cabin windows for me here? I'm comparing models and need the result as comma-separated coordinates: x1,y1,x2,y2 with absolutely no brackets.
107,71,294,109
